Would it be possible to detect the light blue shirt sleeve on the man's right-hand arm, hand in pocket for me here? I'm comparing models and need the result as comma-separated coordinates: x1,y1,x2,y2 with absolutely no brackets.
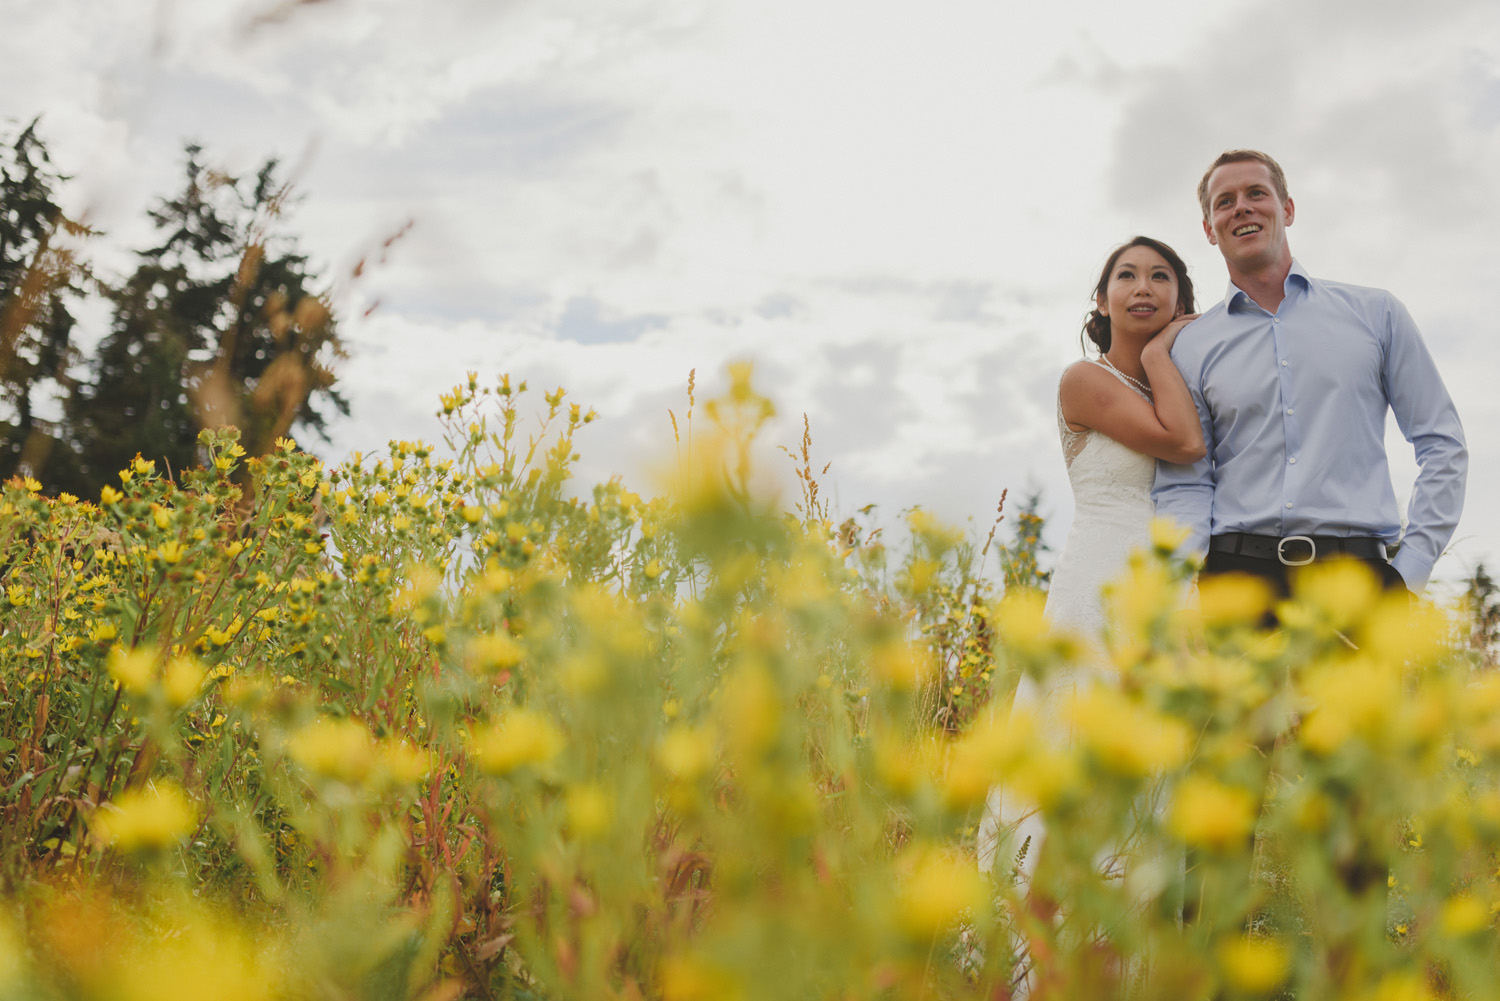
1380,297,1469,591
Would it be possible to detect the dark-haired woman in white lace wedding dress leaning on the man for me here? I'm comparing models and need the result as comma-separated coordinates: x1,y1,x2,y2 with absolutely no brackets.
978,236,1205,879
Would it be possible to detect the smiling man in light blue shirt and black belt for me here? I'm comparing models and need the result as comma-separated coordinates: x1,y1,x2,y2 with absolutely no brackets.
1152,150,1469,593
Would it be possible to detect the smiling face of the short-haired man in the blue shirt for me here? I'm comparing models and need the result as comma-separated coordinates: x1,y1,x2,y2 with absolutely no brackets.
1203,161,1296,273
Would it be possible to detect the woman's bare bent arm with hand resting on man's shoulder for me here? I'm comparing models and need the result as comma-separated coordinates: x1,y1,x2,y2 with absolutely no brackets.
1059,315,1206,464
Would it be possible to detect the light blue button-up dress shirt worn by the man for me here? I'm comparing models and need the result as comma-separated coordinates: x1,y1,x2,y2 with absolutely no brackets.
1152,261,1469,591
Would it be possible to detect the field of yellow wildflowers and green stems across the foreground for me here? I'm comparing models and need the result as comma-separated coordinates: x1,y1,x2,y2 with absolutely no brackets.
0,369,1500,1001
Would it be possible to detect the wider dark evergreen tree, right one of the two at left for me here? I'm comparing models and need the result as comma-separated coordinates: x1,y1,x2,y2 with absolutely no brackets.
50,146,348,494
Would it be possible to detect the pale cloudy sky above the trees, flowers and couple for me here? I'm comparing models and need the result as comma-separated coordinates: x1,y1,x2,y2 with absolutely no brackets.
0,0,1500,591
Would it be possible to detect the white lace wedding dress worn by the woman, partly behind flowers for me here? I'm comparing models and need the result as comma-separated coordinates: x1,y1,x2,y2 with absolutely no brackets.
978,359,1157,879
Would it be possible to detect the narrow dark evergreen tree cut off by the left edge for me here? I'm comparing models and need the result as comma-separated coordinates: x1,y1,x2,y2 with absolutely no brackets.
0,119,89,479
